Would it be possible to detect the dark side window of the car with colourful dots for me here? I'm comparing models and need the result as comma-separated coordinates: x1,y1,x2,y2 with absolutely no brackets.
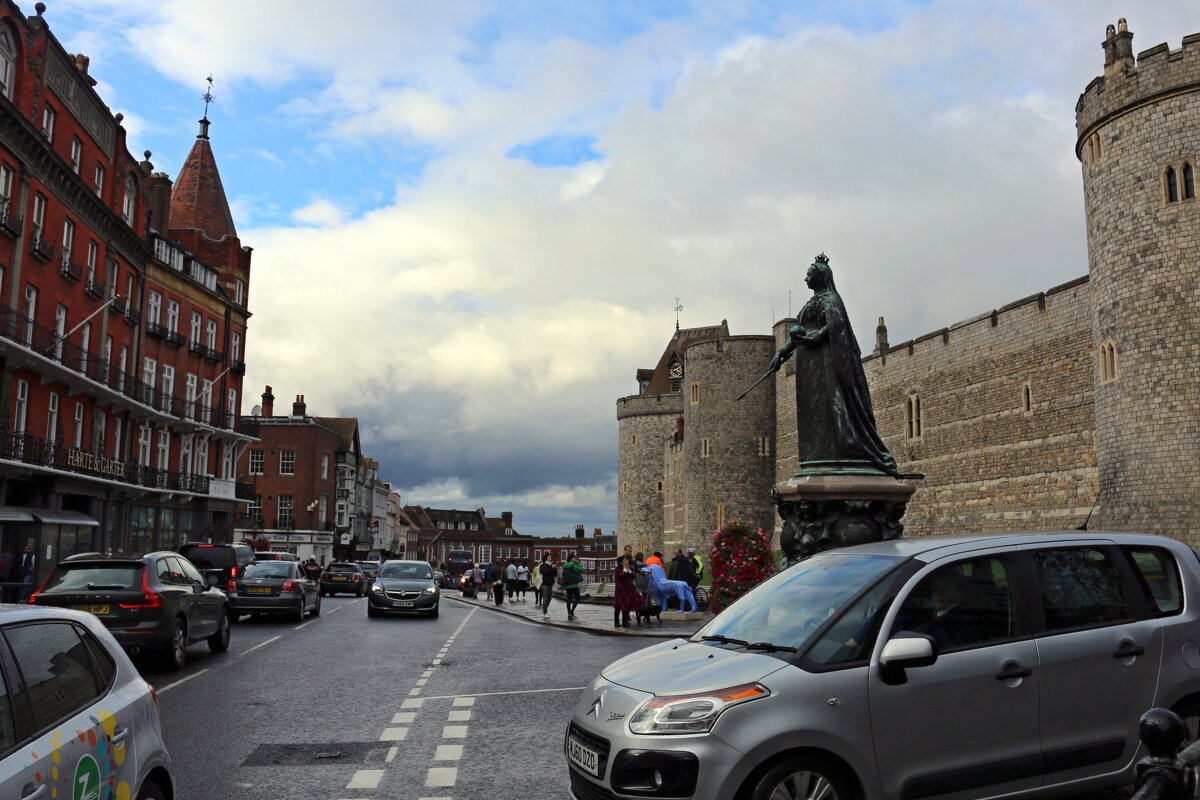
4,622,101,730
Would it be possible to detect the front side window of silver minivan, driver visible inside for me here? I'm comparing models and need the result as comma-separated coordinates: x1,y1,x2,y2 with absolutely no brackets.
895,555,1018,651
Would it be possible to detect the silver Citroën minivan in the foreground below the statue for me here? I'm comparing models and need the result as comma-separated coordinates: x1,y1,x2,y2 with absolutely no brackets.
564,533,1200,800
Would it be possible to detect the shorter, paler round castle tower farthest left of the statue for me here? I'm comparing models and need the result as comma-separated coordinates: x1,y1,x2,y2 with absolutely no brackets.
617,395,683,549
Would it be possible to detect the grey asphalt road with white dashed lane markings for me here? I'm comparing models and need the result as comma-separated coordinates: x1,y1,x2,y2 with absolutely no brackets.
139,597,655,800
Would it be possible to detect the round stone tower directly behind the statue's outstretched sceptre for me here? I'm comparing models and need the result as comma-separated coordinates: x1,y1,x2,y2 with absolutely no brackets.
676,336,775,548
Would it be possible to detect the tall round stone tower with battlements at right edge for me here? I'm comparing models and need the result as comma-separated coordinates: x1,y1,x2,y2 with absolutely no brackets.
1075,19,1200,545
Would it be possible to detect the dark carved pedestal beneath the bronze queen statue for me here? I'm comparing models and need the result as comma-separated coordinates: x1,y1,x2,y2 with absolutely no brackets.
772,475,916,564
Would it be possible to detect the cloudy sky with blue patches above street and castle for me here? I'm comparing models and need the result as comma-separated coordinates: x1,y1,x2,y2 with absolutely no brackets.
39,0,1200,535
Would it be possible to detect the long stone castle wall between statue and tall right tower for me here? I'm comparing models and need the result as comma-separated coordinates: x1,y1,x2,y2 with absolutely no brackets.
863,278,1098,536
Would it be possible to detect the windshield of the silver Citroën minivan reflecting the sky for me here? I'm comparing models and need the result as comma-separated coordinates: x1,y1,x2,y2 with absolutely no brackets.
694,553,899,648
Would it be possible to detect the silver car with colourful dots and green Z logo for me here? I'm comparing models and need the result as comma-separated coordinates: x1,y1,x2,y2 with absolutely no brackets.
0,606,175,800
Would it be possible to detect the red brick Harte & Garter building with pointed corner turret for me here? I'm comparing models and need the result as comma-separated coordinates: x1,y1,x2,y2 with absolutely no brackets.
0,0,251,587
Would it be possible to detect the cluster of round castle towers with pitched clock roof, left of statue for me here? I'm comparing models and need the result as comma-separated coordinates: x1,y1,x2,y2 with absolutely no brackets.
617,321,775,552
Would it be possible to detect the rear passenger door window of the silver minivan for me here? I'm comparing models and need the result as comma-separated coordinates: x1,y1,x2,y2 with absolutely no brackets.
1033,547,1133,632
